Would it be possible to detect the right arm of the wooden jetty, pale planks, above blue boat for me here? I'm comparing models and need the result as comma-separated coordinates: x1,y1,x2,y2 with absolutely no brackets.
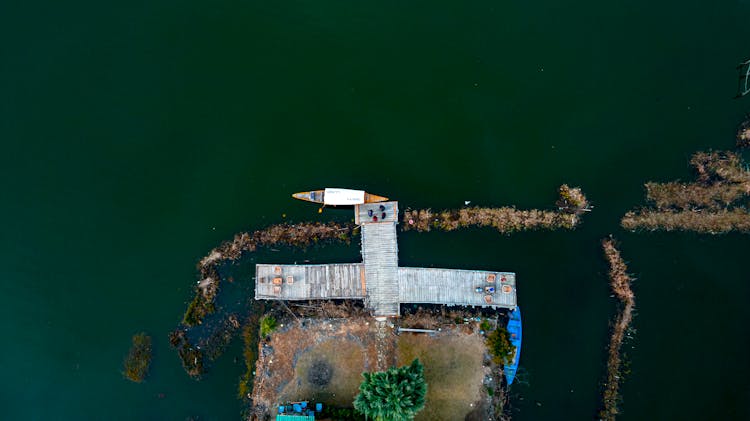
398,268,516,308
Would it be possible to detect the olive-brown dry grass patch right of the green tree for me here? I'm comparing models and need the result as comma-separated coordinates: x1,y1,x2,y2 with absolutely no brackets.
397,330,486,420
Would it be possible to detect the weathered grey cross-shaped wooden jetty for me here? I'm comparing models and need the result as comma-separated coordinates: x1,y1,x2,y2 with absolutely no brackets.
255,202,516,317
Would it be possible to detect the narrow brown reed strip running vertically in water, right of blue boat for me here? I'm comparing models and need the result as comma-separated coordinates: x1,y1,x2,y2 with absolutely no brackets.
599,238,635,420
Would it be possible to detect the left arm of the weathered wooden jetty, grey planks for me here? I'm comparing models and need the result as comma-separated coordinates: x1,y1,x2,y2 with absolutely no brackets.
255,263,365,300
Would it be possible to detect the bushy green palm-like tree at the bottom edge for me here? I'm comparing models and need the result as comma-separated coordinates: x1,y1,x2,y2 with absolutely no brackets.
354,359,427,421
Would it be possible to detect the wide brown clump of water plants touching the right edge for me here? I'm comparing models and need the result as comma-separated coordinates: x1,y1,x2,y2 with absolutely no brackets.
621,152,750,234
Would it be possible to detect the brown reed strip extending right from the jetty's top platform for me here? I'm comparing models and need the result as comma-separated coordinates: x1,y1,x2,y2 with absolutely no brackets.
403,184,591,234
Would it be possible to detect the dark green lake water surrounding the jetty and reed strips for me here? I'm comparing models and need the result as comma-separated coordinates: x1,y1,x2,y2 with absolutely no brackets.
0,0,750,420
